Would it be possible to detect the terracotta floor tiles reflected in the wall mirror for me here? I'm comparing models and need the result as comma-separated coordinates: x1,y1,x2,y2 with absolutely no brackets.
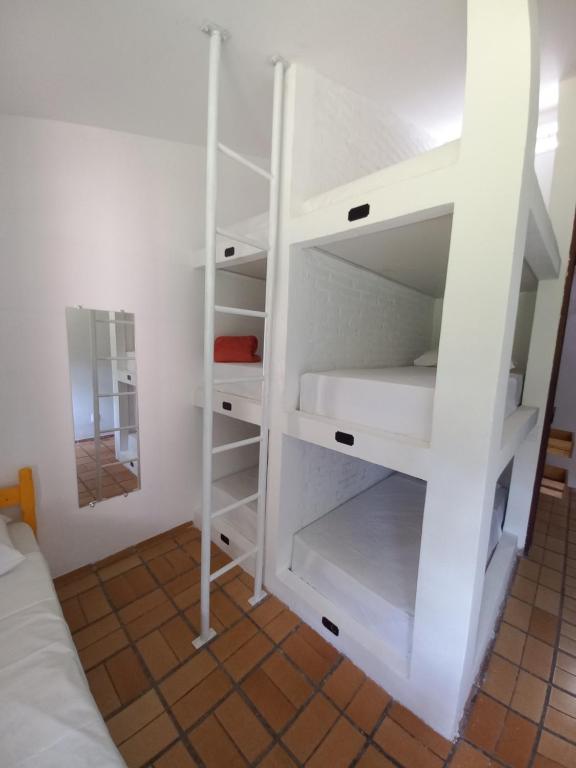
75,436,138,507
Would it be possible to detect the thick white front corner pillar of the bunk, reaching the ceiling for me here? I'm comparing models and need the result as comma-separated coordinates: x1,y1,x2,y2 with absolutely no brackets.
411,0,538,736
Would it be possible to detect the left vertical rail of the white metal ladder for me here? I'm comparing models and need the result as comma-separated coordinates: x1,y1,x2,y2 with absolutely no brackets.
194,27,223,648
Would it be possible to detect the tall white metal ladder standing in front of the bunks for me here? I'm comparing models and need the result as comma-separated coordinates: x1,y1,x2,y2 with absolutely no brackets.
194,25,286,648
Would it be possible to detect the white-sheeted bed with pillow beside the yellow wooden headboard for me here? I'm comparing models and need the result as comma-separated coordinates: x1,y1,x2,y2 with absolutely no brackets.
0,523,125,768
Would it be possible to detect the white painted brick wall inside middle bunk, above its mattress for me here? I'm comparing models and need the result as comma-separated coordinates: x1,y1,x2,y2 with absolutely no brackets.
288,250,434,392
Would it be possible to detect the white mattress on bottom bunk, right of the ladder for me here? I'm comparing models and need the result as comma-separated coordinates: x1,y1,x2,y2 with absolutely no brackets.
292,473,426,653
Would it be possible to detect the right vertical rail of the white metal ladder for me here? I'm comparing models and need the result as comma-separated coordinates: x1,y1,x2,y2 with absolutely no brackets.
248,57,286,605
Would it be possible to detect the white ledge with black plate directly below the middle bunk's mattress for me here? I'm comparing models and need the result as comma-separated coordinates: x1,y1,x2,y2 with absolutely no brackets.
284,411,430,480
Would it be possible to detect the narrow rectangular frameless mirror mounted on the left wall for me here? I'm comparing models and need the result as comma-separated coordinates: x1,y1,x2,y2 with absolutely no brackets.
66,307,140,507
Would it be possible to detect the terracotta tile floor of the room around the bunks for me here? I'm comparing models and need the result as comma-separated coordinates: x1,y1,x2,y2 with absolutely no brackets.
56,488,576,768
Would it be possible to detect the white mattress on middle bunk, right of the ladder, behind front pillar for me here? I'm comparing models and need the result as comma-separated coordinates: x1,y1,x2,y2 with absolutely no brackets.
300,366,523,441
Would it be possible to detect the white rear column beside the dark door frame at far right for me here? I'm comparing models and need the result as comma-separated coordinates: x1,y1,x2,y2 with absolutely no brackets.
506,77,576,547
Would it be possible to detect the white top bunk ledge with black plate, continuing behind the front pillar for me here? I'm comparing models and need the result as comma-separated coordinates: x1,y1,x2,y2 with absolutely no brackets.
288,141,560,280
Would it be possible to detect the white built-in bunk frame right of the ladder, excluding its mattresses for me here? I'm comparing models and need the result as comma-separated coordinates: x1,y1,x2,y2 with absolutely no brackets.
266,0,561,737
